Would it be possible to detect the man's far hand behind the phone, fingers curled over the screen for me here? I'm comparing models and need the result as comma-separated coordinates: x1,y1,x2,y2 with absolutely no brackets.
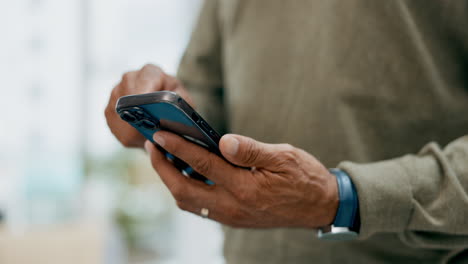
105,64,193,148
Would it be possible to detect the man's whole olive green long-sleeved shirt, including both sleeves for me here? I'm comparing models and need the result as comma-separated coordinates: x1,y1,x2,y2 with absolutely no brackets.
178,0,468,264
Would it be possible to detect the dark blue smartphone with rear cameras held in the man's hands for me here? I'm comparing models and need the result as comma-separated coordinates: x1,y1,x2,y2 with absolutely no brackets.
116,91,222,185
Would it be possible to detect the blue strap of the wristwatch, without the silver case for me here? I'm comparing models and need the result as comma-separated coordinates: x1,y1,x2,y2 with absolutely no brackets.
330,169,359,227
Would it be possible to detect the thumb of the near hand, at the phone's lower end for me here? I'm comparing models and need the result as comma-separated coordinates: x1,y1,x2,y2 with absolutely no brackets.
219,134,275,168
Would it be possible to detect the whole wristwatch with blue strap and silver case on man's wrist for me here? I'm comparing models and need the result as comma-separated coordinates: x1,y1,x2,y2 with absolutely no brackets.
317,169,361,241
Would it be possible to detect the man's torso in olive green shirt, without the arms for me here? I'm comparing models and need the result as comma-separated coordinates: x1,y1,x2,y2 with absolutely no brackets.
219,0,468,264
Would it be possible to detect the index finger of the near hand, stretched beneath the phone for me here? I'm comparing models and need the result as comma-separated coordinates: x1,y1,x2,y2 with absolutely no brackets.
153,131,242,186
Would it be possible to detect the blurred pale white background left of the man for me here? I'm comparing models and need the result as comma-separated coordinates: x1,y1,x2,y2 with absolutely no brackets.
0,0,223,264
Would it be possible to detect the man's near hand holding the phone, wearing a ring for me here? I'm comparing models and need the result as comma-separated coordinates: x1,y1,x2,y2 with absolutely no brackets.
145,131,338,228
